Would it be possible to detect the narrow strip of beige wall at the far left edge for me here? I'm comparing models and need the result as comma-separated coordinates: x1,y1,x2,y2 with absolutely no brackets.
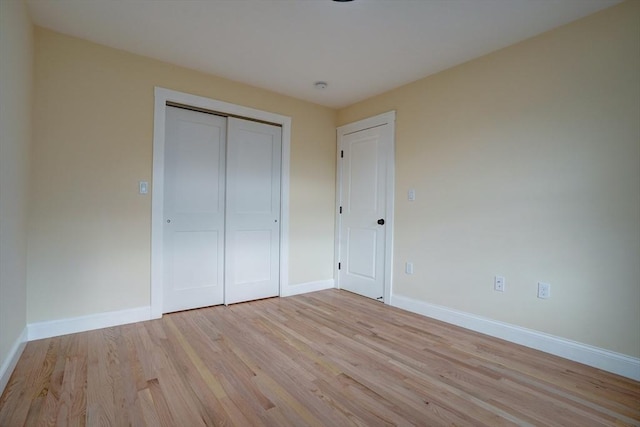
0,0,33,366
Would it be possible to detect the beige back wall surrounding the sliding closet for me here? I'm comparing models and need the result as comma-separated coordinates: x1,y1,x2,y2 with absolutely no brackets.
28,28,336,322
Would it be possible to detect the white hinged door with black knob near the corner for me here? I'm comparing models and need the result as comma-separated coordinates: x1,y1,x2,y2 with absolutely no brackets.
338,118,393,300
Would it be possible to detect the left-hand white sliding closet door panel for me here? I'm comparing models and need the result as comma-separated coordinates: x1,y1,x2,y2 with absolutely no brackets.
163,107,226,313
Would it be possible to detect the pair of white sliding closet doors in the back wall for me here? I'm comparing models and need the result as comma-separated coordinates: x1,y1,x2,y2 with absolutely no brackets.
162,106,282,313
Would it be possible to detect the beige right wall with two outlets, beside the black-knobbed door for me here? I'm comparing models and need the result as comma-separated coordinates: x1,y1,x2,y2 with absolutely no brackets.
338,1,640,357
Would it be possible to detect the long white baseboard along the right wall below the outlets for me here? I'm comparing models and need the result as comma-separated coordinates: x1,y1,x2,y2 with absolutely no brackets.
391,295,640,381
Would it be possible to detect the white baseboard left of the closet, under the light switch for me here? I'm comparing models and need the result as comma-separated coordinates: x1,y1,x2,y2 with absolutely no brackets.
27,307,151,341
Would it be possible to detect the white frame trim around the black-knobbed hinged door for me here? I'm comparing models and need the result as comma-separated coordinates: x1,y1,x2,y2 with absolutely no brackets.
333,110,396,304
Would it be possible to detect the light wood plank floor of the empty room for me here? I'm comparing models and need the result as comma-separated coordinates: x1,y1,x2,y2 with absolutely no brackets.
0,290,640,427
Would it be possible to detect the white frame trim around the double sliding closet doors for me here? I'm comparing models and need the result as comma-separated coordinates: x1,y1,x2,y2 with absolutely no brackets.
151,86,291,319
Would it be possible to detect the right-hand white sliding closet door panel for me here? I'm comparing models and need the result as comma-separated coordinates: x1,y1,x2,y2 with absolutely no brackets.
225,117,282,304
